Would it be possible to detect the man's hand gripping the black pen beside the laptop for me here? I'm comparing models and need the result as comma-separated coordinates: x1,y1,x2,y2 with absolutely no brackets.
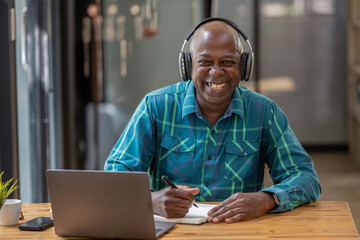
151,185,199,218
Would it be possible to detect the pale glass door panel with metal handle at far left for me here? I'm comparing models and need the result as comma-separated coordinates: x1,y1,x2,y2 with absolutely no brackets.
15,0,56,202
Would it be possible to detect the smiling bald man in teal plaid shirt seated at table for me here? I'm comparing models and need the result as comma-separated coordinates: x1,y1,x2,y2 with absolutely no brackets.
104,19,321,223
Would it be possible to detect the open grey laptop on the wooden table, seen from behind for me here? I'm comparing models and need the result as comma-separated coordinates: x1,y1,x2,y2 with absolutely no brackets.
46,170,175,239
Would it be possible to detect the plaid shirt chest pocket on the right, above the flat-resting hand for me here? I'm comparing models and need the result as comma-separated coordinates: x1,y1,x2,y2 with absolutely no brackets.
225,140,259,184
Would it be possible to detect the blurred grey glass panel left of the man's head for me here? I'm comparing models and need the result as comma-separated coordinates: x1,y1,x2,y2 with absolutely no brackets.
82,0,203,169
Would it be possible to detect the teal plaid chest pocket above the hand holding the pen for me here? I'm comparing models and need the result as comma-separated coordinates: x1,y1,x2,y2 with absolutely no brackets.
159,136,196,180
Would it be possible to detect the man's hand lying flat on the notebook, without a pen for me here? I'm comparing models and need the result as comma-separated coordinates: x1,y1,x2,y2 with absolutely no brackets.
208,192,276,223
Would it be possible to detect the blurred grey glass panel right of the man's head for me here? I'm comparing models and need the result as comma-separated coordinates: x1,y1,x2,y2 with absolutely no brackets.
213,0,347,146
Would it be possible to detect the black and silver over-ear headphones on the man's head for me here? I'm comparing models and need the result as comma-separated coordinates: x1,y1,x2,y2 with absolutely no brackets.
179,17,254,81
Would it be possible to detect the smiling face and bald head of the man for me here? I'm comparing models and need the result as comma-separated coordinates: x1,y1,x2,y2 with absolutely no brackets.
191,25,240,110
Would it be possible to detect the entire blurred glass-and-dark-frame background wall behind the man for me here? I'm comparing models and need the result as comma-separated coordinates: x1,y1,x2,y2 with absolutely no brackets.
0,0,360,208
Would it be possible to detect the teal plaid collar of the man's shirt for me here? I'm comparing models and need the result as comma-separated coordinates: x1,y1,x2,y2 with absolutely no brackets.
182,81,244,118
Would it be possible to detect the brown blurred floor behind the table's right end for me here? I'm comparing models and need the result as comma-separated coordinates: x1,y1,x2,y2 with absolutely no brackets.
309,152,360,233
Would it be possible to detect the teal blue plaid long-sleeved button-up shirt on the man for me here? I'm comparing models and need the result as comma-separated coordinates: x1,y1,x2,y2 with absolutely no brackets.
104,81,321,212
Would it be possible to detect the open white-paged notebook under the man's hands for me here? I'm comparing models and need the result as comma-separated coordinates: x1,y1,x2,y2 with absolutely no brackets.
154,203,216,224
